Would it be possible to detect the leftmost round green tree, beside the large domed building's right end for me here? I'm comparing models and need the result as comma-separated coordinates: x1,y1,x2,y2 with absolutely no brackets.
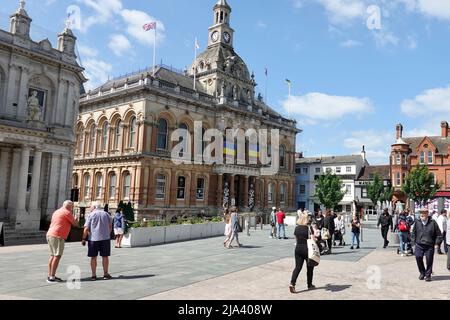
316,172,345,209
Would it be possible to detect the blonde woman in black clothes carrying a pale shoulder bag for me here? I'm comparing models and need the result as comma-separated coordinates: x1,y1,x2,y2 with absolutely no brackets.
289,214,320,293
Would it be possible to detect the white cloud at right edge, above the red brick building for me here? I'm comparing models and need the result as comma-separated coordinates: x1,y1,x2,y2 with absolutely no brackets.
401,85,450,117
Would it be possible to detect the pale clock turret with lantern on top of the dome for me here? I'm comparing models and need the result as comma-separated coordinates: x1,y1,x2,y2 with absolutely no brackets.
208,0,234,47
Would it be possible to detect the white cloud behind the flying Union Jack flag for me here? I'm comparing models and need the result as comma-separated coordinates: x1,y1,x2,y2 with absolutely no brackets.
121,9,165,46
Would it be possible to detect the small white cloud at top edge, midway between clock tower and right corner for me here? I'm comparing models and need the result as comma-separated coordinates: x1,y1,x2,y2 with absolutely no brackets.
318,0,367,24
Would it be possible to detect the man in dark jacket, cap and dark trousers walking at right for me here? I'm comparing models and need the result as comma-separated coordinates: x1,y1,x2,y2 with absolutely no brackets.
411,209,442,282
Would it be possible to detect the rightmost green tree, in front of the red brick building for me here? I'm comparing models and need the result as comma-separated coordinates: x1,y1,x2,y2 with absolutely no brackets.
402,166,441,207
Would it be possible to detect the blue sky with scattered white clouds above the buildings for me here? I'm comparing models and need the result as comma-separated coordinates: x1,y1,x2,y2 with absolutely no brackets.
0,0,450,165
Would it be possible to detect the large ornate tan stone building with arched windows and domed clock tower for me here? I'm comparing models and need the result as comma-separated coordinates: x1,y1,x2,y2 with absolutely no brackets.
73,0,300,218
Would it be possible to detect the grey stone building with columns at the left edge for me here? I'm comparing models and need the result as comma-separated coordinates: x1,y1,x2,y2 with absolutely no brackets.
0,0,86,231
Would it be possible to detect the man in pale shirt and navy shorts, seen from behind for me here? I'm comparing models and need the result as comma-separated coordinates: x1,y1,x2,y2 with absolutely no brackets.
82,202,112,281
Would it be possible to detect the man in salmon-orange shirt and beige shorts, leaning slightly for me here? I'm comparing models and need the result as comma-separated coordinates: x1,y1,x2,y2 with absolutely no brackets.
46,200,78,283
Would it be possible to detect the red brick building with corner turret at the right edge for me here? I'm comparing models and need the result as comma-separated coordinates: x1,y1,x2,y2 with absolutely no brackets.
390,121,450,210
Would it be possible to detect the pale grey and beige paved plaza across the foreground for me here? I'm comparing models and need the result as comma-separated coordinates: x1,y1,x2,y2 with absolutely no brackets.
0,220,450,300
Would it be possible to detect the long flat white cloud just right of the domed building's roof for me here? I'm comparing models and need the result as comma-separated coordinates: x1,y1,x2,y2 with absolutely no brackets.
282,92,374,120
